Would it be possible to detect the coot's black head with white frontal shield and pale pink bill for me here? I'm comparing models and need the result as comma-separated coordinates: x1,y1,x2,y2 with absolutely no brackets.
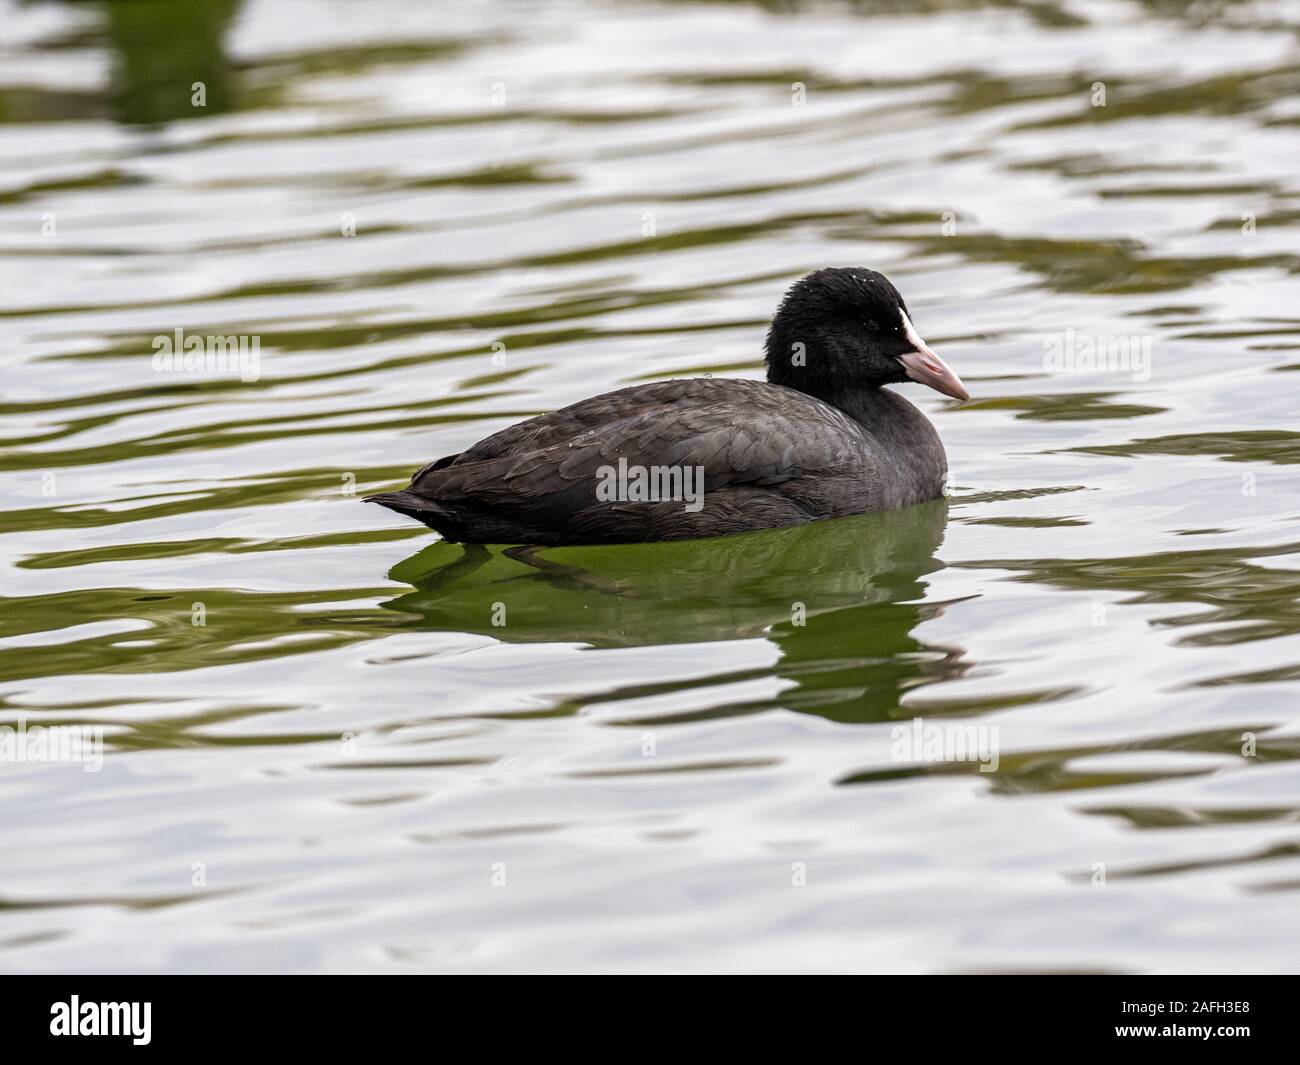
767,267,970,399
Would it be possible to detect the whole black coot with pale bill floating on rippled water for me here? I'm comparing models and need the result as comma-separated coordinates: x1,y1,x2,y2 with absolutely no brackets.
367,268,970,545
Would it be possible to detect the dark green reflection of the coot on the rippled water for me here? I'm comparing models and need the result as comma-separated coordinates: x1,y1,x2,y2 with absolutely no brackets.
385,499,970,723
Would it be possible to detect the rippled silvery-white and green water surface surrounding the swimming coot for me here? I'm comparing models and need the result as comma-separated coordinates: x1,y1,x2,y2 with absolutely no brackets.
0,0,1300,973
